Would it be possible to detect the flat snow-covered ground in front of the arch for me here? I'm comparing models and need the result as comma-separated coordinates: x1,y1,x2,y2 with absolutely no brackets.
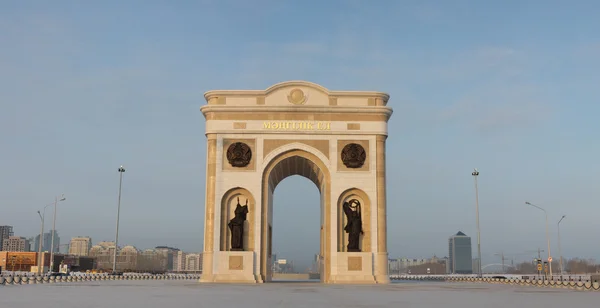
0,280,600,308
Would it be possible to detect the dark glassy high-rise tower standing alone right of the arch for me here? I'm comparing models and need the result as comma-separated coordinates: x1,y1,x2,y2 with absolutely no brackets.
448,231,473,274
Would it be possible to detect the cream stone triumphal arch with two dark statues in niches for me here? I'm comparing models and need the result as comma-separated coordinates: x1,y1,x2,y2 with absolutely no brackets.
200,81,392,283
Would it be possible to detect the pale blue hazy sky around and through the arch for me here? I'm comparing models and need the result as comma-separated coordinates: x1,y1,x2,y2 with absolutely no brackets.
0,0,600,270
